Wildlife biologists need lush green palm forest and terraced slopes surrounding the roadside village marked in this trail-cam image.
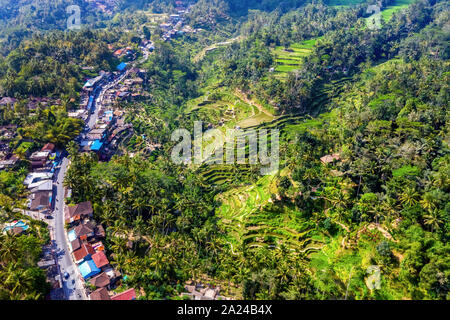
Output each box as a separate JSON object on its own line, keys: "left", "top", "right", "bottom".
{"left": 0, "top": 0, "right": 450, "bottom": 300}
